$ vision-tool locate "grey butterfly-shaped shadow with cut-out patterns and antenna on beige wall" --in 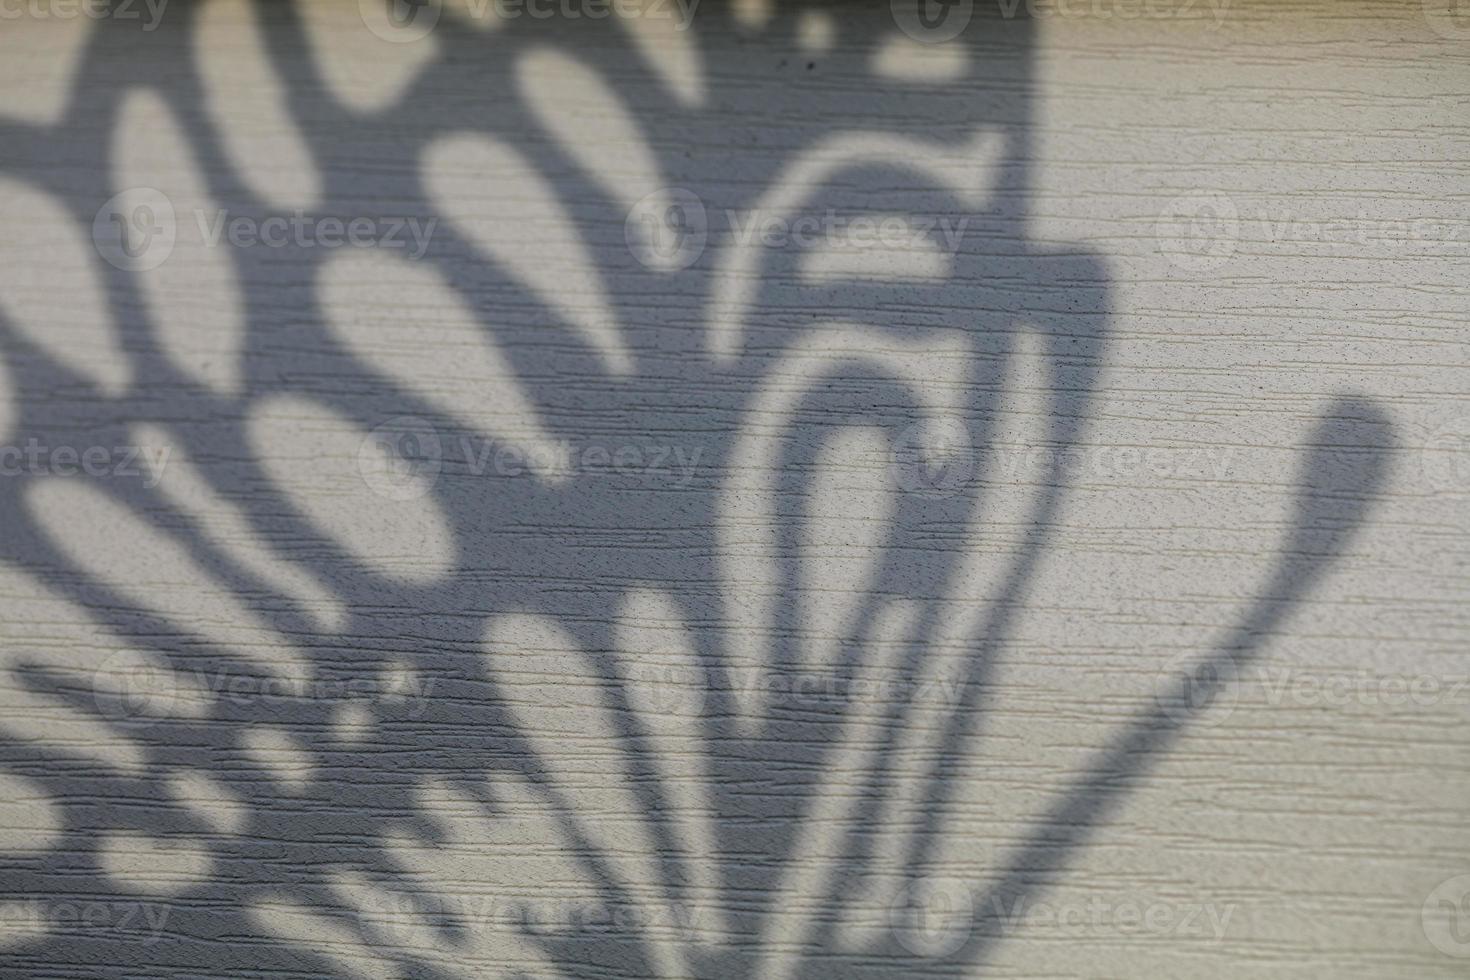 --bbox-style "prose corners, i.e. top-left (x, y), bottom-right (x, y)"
top-left (0, 0), bottom-right (1389, 979)
